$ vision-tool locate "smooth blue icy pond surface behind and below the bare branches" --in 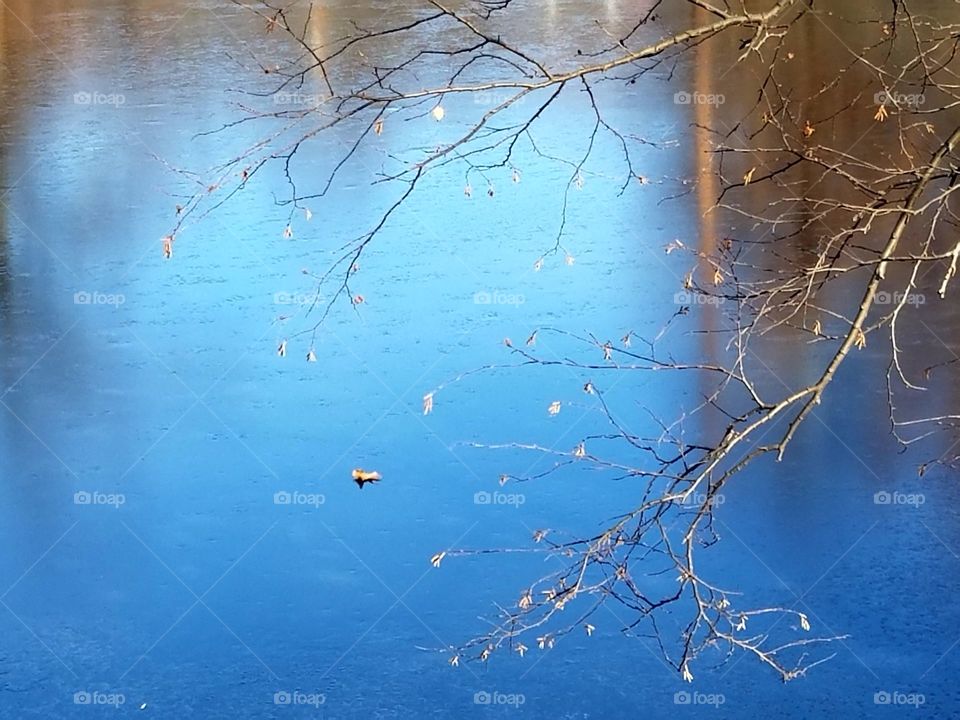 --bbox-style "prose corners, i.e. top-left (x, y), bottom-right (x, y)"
top-left (0, 0), bottom-right (960, 719)
